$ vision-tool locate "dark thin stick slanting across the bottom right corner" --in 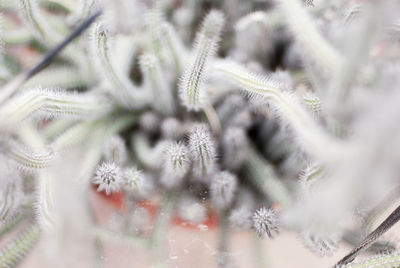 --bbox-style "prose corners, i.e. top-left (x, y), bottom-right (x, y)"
top-left (334, 206), bottom-right (400, 267)
